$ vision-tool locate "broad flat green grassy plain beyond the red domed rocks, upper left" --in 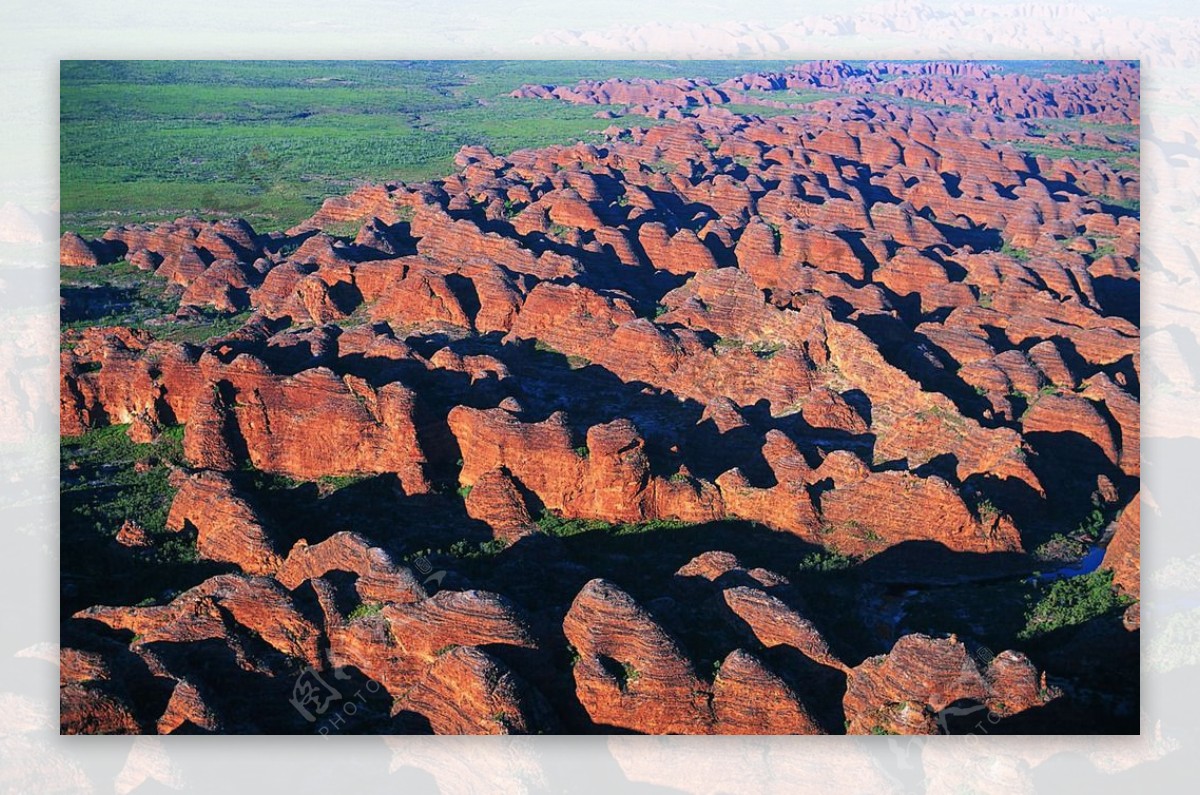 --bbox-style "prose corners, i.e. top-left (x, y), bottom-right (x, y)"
top-left (60, 61), bottom-right (786, 234)
